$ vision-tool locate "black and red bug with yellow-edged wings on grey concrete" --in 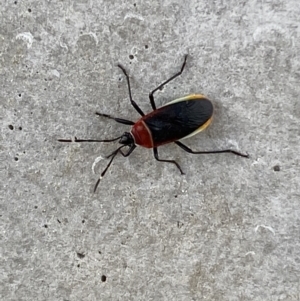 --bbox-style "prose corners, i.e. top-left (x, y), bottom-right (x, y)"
top-left (58, 55), bottom-right (248, 192)
